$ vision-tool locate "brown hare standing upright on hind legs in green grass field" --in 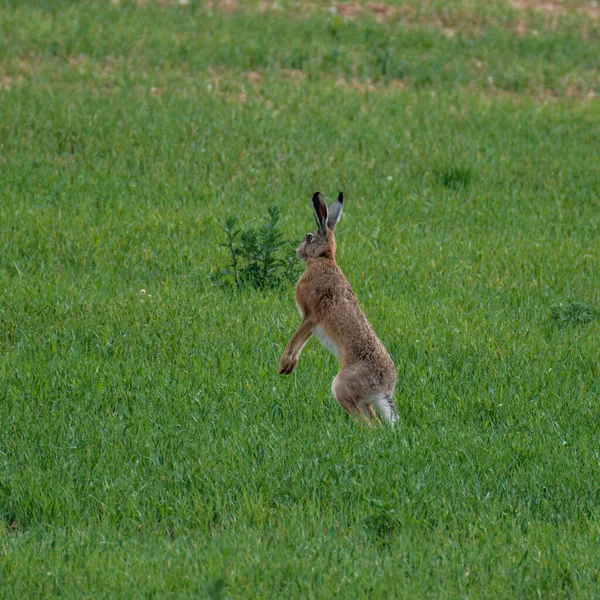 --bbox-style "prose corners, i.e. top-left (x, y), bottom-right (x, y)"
top-left (279, 192), bottom-right (398, 425)
